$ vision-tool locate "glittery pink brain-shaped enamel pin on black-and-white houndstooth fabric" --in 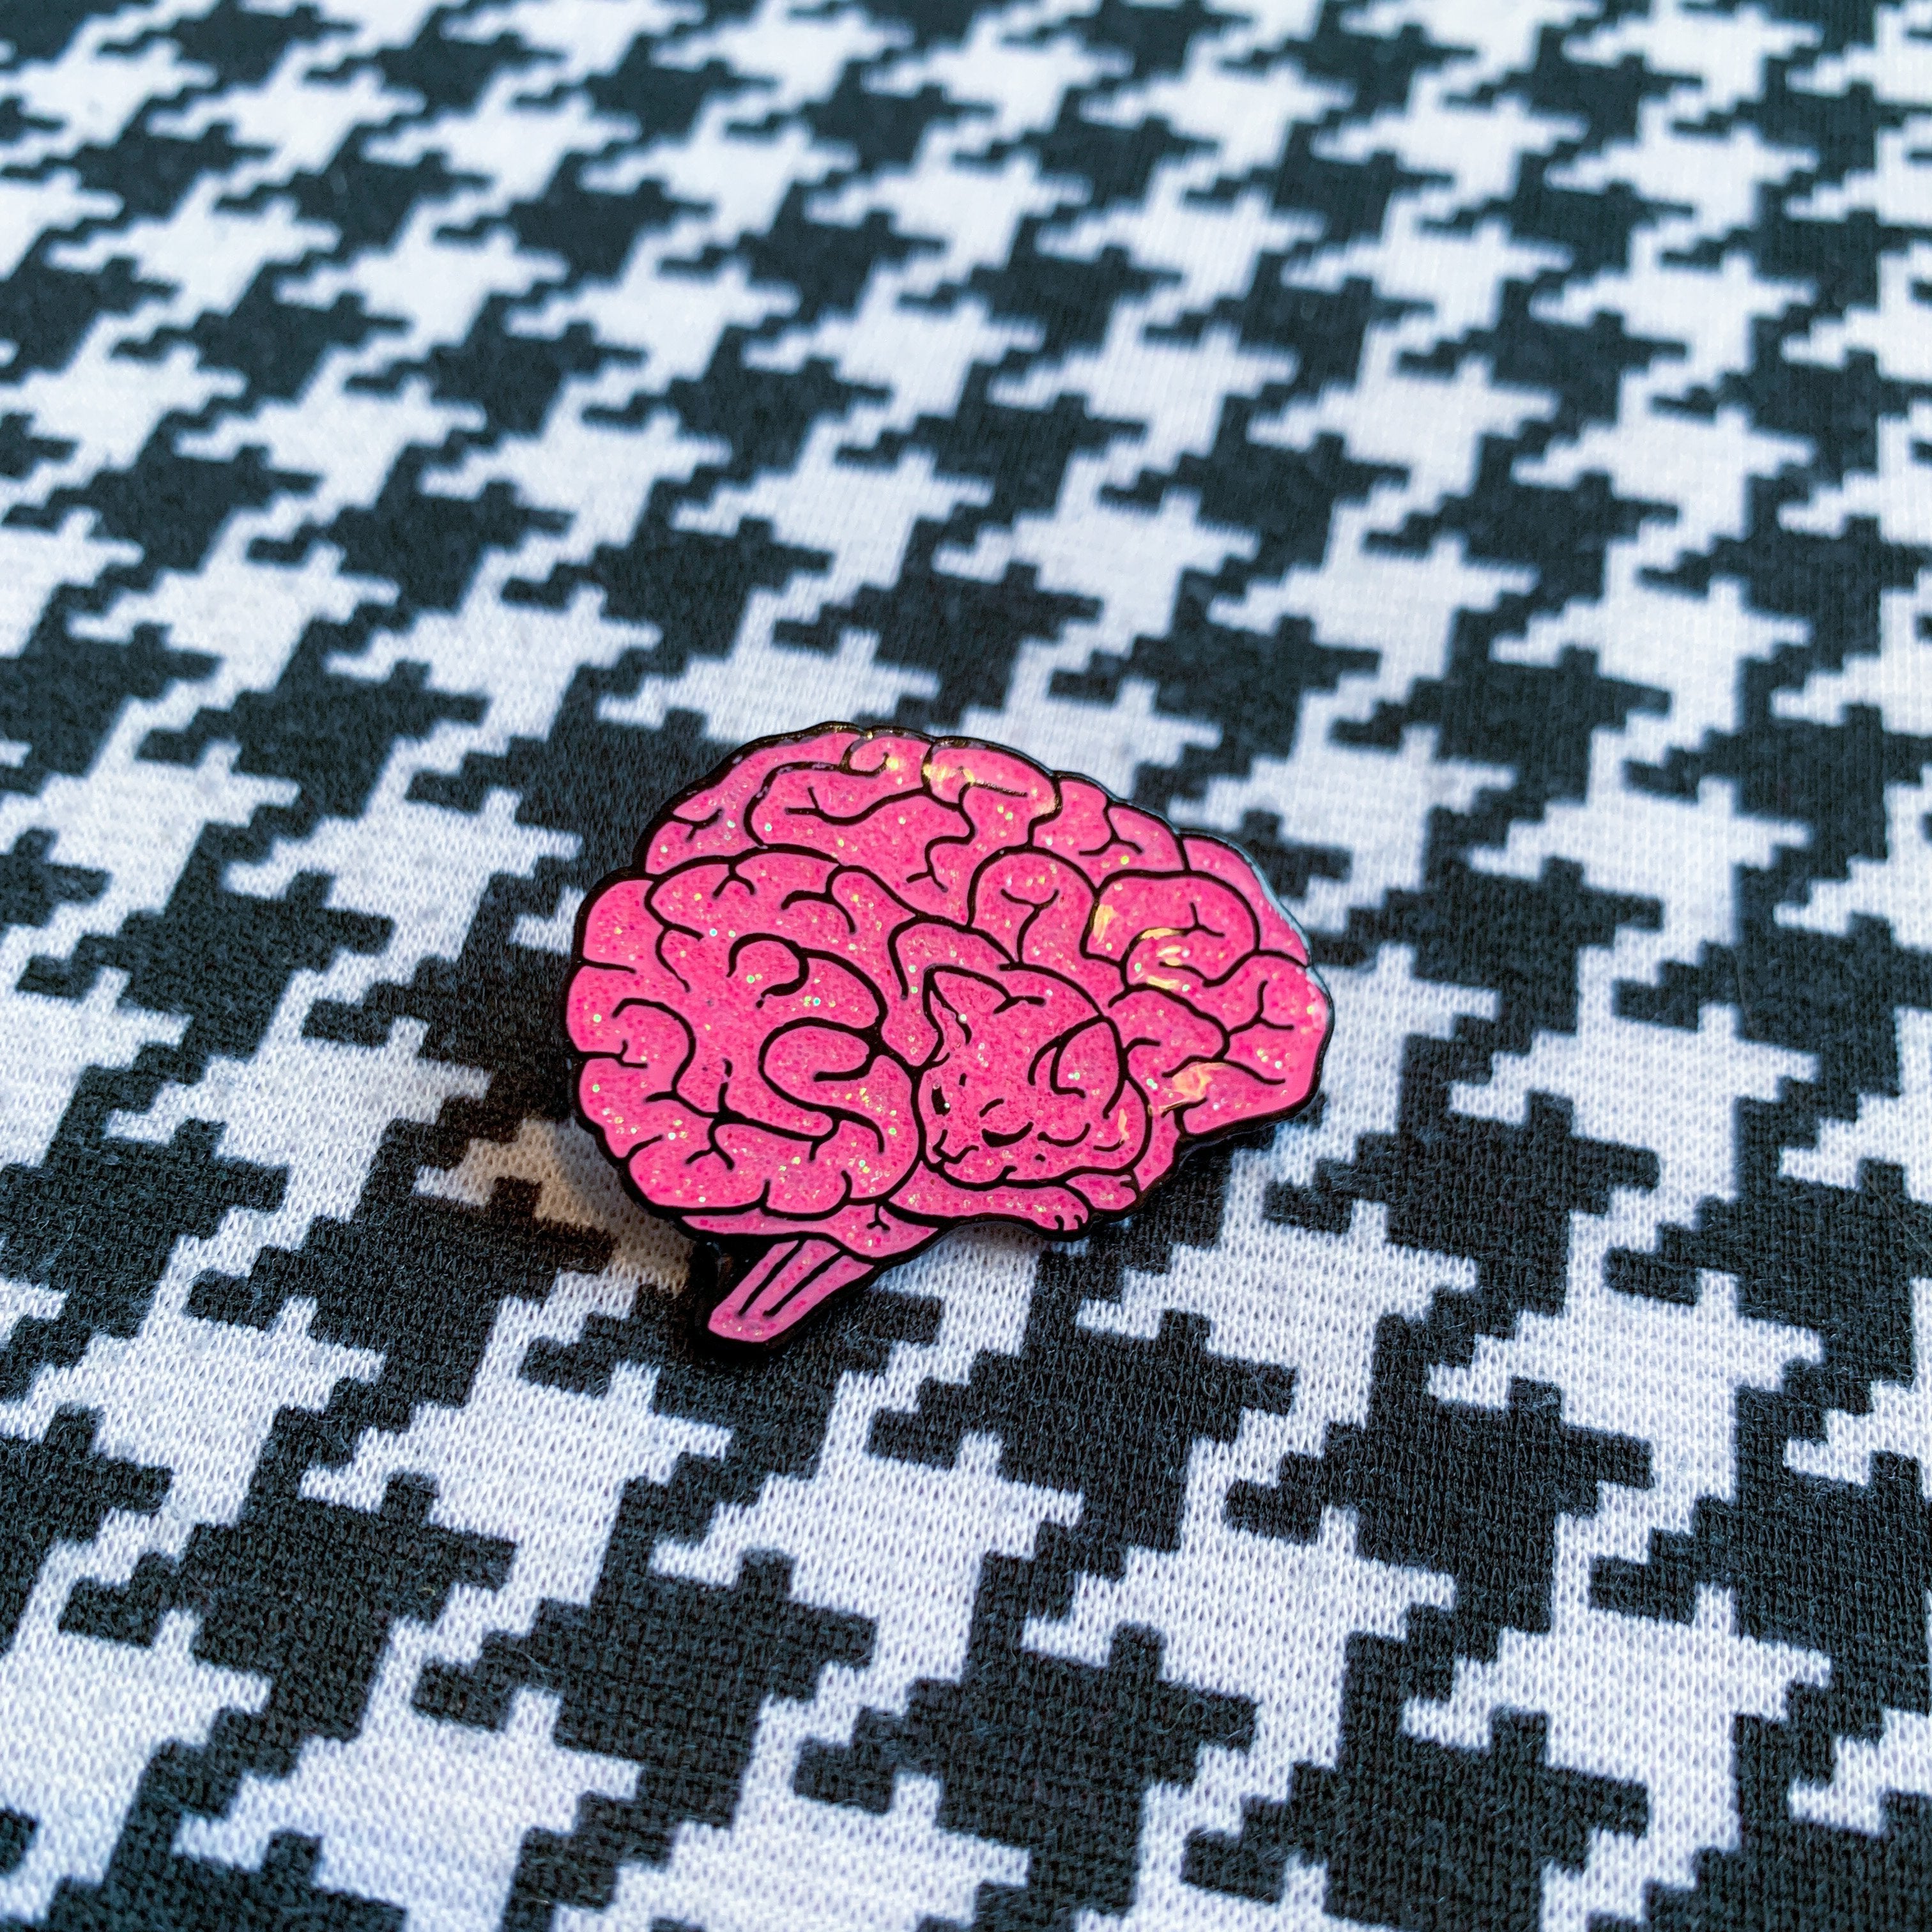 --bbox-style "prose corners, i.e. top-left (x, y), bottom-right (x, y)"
top-left (564, 724), bottom-right (1330, 1343)
